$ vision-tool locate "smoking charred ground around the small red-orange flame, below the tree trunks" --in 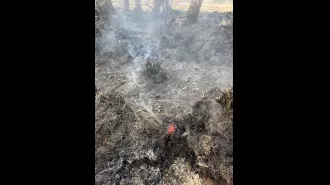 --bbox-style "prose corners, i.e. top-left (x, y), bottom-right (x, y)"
top-left (95, 7), bottom-right (233, 185)
